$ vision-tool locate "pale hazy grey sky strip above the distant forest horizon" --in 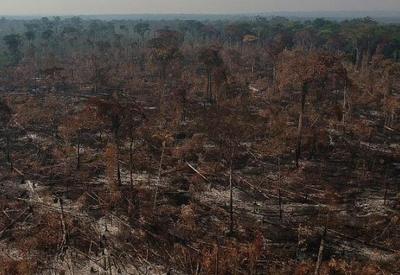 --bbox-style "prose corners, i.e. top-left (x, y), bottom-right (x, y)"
top-left (0, 0), bottom-right (400, 15)
